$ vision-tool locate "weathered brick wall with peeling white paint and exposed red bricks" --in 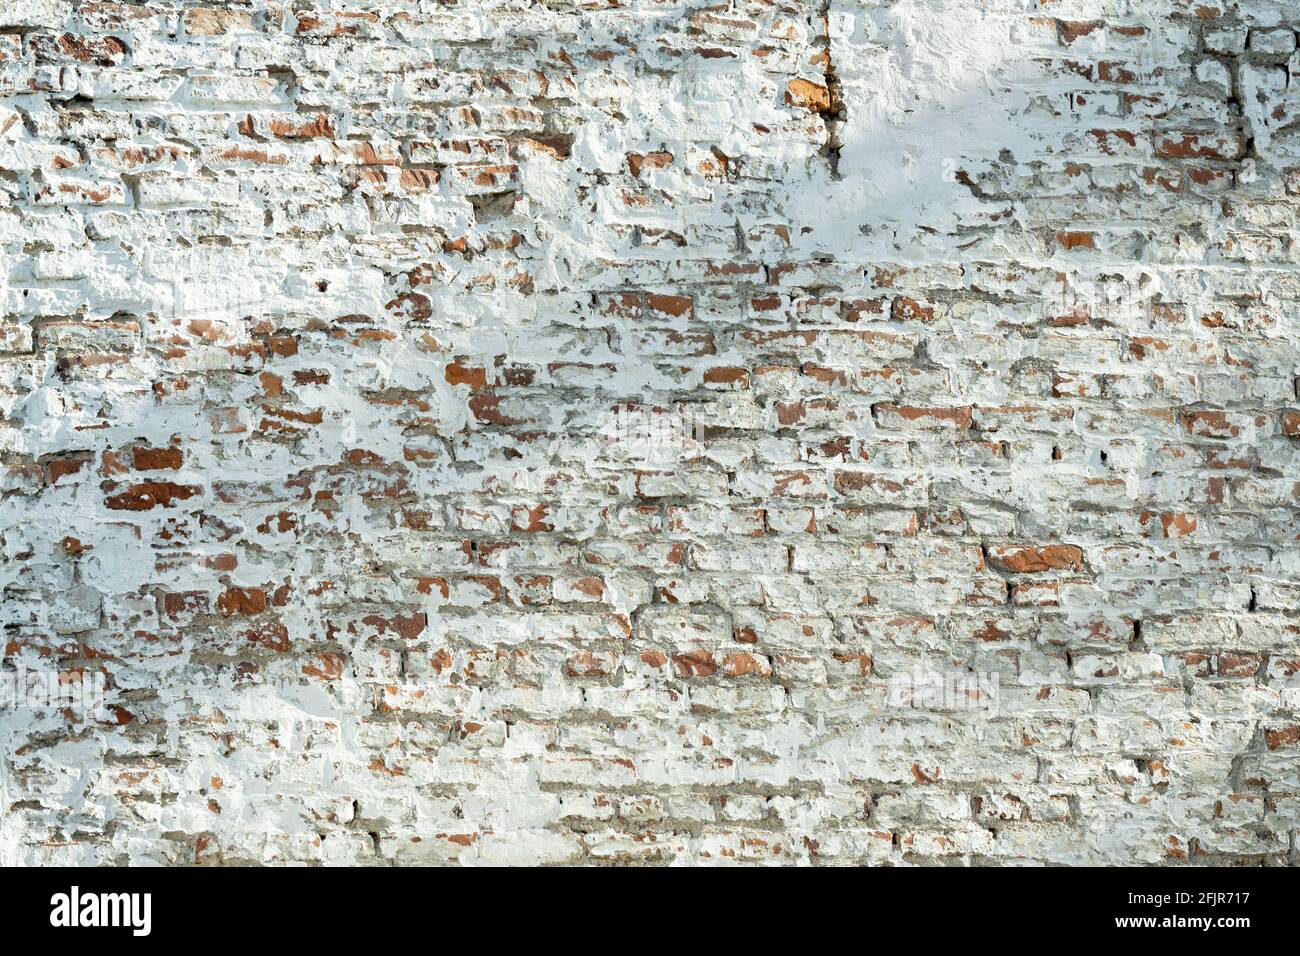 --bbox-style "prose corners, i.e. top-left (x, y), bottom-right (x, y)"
top-left (0, 0), bottom-right (1300, 864)
